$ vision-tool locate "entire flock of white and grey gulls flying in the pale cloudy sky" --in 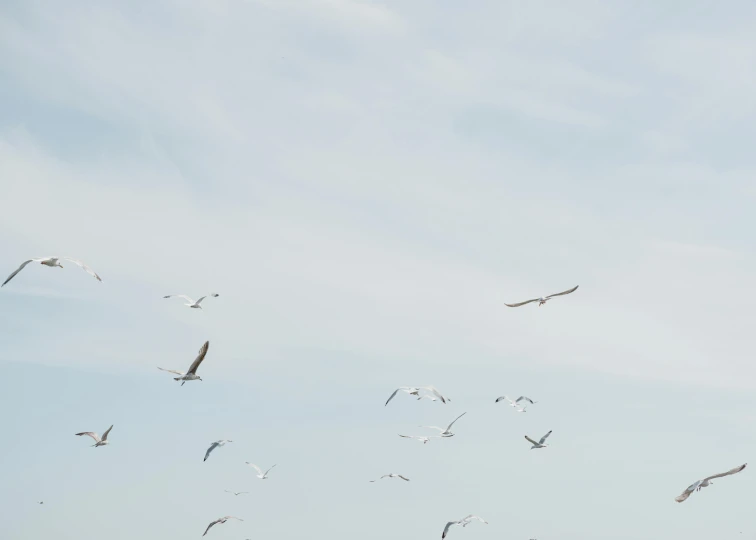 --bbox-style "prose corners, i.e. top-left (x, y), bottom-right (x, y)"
top-left (5, 257), bottom-right (747, 540)
